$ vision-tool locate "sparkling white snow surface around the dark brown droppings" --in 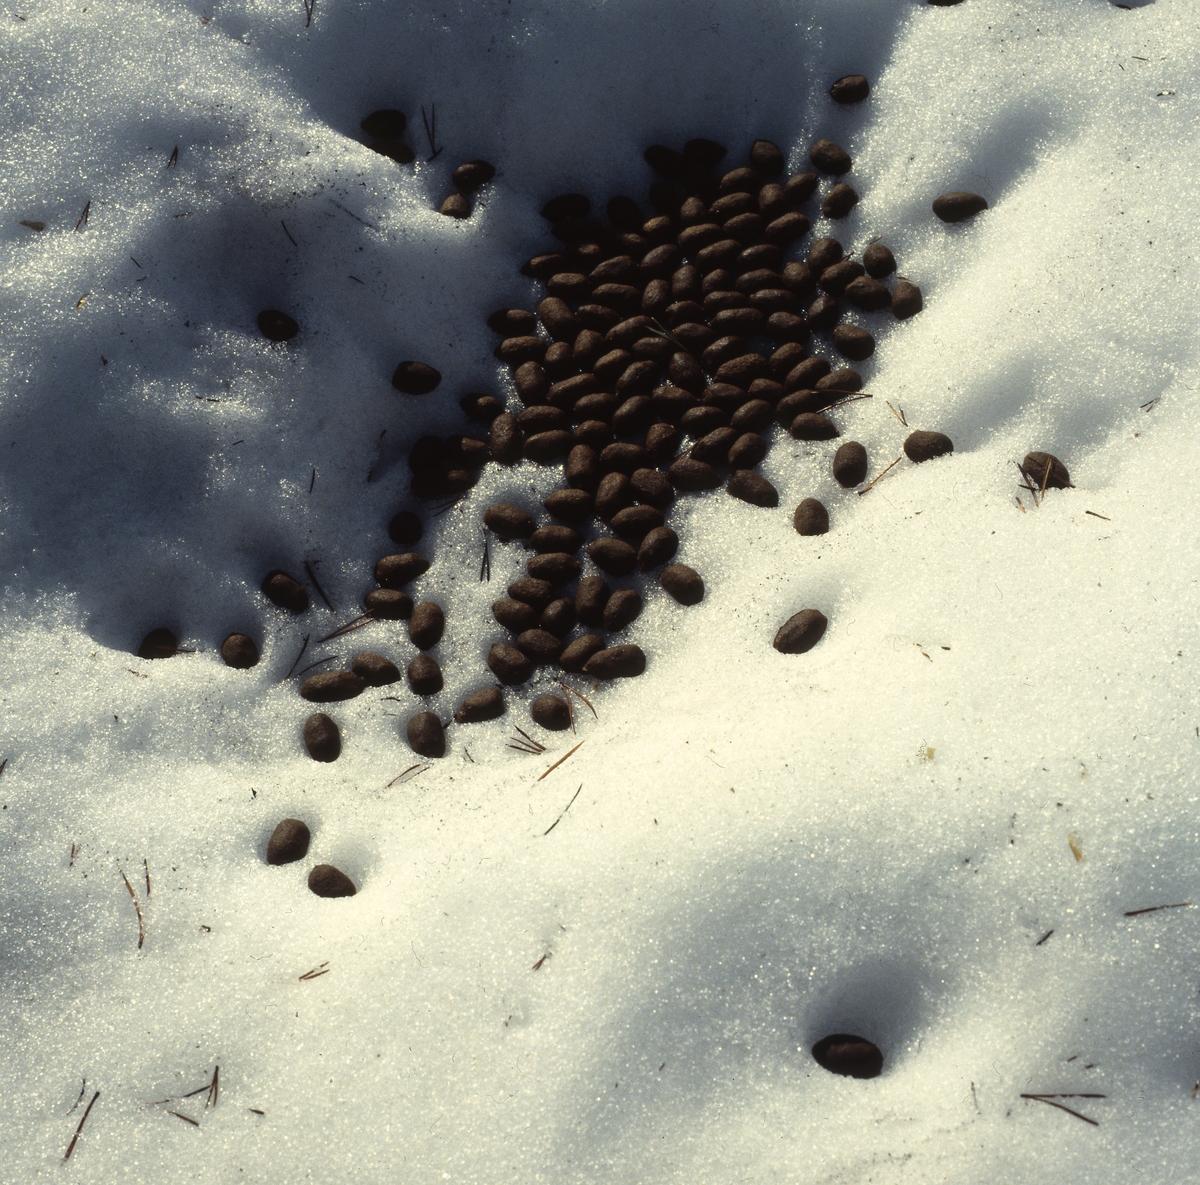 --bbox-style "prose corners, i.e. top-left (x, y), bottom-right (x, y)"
top-left (0, 0), bottom-right (1200, 1183)
